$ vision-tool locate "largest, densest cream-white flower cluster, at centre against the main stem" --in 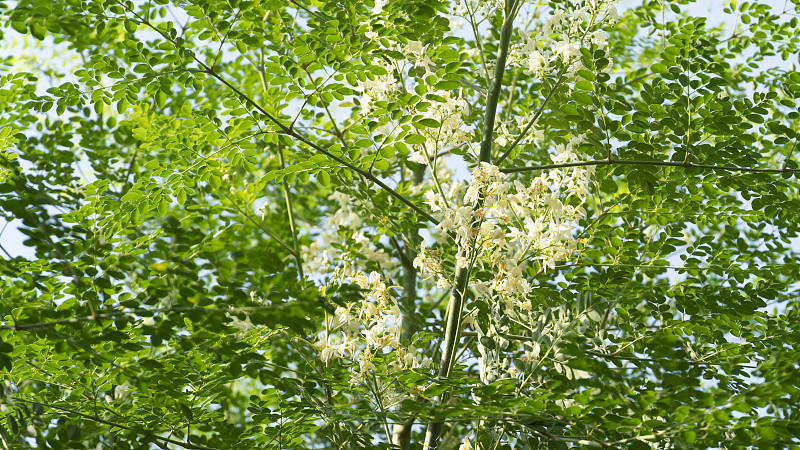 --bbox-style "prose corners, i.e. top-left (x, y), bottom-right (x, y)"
top-left (422, 136), bottom-right (593, 310)
